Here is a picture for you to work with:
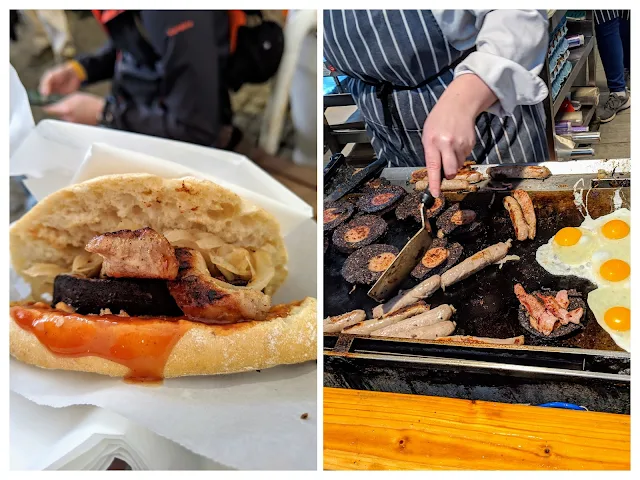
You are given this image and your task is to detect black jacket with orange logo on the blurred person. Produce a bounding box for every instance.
[77,10,232,146]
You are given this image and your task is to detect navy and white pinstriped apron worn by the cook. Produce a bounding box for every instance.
[324,10,548,167]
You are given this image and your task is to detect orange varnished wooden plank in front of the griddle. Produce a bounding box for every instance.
[324,388,631,470]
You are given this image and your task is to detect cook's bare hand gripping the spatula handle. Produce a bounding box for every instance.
[422,74,497,197]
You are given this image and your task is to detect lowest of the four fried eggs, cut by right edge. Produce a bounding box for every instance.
[587,287,631,352]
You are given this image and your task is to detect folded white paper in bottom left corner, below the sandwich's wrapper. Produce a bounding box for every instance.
[9,392,220,470]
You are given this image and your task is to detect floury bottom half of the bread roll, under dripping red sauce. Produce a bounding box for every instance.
[9,298,317,378]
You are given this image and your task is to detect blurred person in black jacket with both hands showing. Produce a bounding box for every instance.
[39,10,283,161]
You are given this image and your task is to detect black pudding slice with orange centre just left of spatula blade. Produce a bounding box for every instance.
[342,244,400,285]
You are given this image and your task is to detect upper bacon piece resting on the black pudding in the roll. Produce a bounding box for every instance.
[85,227,178,280]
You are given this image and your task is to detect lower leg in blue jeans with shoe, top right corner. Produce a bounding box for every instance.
[593,10,631,123]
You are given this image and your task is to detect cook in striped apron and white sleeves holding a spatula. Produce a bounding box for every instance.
[324,10,548,195]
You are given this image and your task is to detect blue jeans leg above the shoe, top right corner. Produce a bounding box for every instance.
[596,18,631,92]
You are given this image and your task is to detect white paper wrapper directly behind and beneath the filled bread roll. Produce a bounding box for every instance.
[10,122,317,470]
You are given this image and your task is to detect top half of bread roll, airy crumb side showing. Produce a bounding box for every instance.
[10,174,287,295]
